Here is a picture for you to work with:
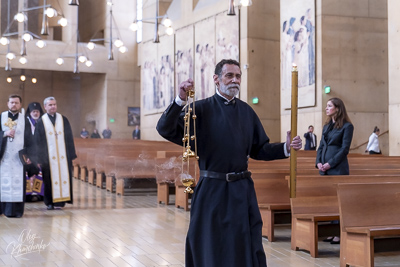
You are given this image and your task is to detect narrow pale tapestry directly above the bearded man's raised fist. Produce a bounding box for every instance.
[175,25,194,97]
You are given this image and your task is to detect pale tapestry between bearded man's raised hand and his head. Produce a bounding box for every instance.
[194,17,215,99]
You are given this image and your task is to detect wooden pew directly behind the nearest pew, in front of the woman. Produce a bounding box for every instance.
[291,175,400,257]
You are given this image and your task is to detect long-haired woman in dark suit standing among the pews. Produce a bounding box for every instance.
[316,98,354,244]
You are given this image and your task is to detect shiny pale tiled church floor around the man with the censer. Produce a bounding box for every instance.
[0,180,400,267]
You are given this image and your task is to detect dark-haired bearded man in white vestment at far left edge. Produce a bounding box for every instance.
[0,95,37,218]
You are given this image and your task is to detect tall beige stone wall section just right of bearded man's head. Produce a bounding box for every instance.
[240,0,282,142]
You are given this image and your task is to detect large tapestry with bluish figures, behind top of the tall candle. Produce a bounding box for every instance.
[280,0,316,109]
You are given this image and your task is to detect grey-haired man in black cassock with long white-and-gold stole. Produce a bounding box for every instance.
[34,96,76,210]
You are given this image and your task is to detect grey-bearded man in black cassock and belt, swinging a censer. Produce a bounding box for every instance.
[157,60,302,267]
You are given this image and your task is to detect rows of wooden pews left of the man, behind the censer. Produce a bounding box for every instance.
[73,139,198,211]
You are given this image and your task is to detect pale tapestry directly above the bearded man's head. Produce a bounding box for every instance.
[215,10,239,63]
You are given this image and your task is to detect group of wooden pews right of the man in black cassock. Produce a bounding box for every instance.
[249,151,400,266]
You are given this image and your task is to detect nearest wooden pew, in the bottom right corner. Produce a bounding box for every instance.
[337,183,400,267]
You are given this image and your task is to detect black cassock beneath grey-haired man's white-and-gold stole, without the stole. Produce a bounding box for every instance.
[34,113,76,207]
